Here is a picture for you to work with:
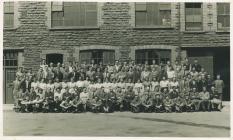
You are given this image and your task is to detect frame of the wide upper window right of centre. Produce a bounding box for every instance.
[134,2,173,29]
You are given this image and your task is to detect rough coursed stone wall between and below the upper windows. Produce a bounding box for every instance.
[3,2,230,70]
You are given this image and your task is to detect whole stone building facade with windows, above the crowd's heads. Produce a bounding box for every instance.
[3,1,230,103]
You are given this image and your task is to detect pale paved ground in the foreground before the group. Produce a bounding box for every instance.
[3,104,230,137]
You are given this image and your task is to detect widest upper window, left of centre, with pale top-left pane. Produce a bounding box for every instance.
[51,2,97,27]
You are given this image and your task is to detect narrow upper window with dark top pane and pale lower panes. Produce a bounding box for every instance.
[185,3,202,31]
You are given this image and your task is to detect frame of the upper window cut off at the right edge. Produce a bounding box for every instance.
[216,2,230,32]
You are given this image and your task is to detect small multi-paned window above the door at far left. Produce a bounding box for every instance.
[3,51,18,67]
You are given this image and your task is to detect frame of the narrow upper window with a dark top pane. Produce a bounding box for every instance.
[184,2,204,32]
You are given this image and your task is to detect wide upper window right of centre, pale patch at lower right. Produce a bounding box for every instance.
[135,2,171,27]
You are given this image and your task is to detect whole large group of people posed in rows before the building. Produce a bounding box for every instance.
[13,58,224,113]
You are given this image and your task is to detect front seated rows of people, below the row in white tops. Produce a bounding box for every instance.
[15,87,222,113]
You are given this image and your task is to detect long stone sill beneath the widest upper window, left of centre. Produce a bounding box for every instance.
[49,26,99,31]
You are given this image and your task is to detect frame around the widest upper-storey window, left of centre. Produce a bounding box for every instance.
[49,1,99,30]
